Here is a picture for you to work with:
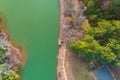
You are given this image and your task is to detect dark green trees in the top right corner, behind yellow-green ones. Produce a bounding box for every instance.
[83,0,120,25]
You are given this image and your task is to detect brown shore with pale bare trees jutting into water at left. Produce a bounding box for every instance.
[0,25,23,80]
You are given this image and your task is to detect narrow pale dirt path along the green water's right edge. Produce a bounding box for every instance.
[57,0,68,80]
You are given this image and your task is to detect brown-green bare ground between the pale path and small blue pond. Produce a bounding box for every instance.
[65,50,94,80]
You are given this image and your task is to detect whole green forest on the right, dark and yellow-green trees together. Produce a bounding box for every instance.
[68,0,120,66]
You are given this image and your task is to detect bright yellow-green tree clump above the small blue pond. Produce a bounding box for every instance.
[68,20,120,66]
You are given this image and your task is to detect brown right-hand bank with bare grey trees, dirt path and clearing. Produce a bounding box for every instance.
[57,0,93,80]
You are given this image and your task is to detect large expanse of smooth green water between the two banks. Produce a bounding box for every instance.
[0,0,59,80]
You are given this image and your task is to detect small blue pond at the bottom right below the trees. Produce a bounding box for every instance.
[94,66,114,80]
